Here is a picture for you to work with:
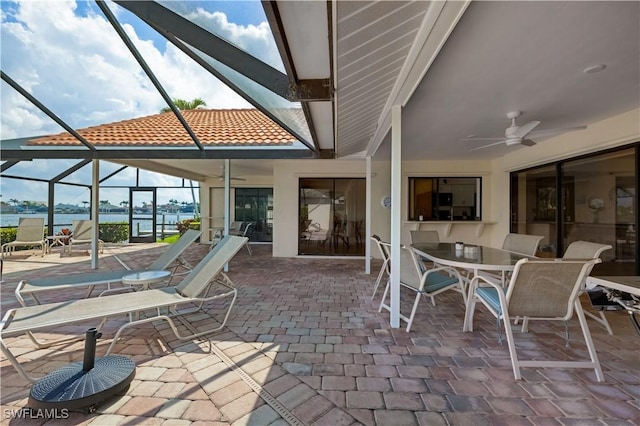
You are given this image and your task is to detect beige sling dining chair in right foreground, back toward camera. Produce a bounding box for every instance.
[463,259,604,382]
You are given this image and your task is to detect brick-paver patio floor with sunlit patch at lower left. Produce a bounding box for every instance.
[0,244,640,425]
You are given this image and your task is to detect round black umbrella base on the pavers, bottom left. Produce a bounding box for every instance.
[27,355,136,413]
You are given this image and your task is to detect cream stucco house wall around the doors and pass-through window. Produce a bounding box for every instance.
[201,109,640,258]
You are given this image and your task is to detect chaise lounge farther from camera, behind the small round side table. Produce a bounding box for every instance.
[15,229,201,306]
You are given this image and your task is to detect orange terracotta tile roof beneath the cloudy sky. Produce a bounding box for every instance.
[29,109,296,147]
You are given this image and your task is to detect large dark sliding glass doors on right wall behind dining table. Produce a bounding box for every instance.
[511,145,640,275]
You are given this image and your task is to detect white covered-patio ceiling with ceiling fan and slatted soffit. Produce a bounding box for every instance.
[298,0,640,159]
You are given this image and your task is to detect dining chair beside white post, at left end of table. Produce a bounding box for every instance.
[378,245,467,332]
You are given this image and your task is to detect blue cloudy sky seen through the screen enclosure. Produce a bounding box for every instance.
[0,0,283,205]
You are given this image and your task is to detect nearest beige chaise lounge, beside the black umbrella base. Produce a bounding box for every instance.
[0,235,247,381]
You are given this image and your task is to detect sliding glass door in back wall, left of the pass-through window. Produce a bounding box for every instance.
[298,178,366,256]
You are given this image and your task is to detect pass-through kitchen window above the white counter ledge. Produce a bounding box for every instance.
[408,177,482,221]
